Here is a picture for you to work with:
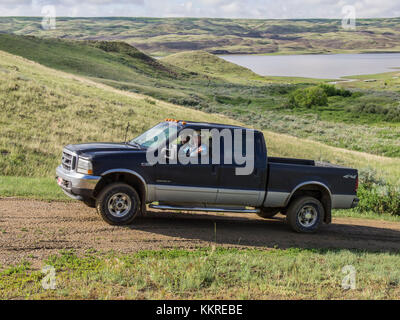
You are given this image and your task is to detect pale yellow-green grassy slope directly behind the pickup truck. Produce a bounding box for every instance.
[0,52,400,186]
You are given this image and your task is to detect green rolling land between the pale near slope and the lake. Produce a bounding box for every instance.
[0,35,400,157]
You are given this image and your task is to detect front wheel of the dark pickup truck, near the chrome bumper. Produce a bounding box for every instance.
[96,183,140,226]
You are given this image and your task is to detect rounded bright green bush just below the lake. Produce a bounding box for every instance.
[289,86,328,108]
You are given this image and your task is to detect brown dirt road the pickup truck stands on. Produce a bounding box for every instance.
[0,199,400,267]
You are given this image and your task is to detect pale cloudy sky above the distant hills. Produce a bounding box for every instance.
[0,0,400,19]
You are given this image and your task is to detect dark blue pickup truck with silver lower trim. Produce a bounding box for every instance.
[56,119,358,232]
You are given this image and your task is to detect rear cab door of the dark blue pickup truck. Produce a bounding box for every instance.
[217,129,267,206]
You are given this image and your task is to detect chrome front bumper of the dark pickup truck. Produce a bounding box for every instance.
[56,166,101,200]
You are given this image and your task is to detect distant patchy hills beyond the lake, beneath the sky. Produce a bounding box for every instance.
[0,17,400,55]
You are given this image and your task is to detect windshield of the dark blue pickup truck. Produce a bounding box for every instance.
[129,122,182,148]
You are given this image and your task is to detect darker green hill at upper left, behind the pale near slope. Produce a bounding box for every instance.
[0,34,190,96]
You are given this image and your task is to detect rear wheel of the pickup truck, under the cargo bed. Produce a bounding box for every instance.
[286,197,325,233]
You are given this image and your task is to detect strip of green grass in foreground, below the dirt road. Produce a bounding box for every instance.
[0,248,400,300]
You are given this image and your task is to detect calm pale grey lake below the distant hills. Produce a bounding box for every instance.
[219,53,400,79]
